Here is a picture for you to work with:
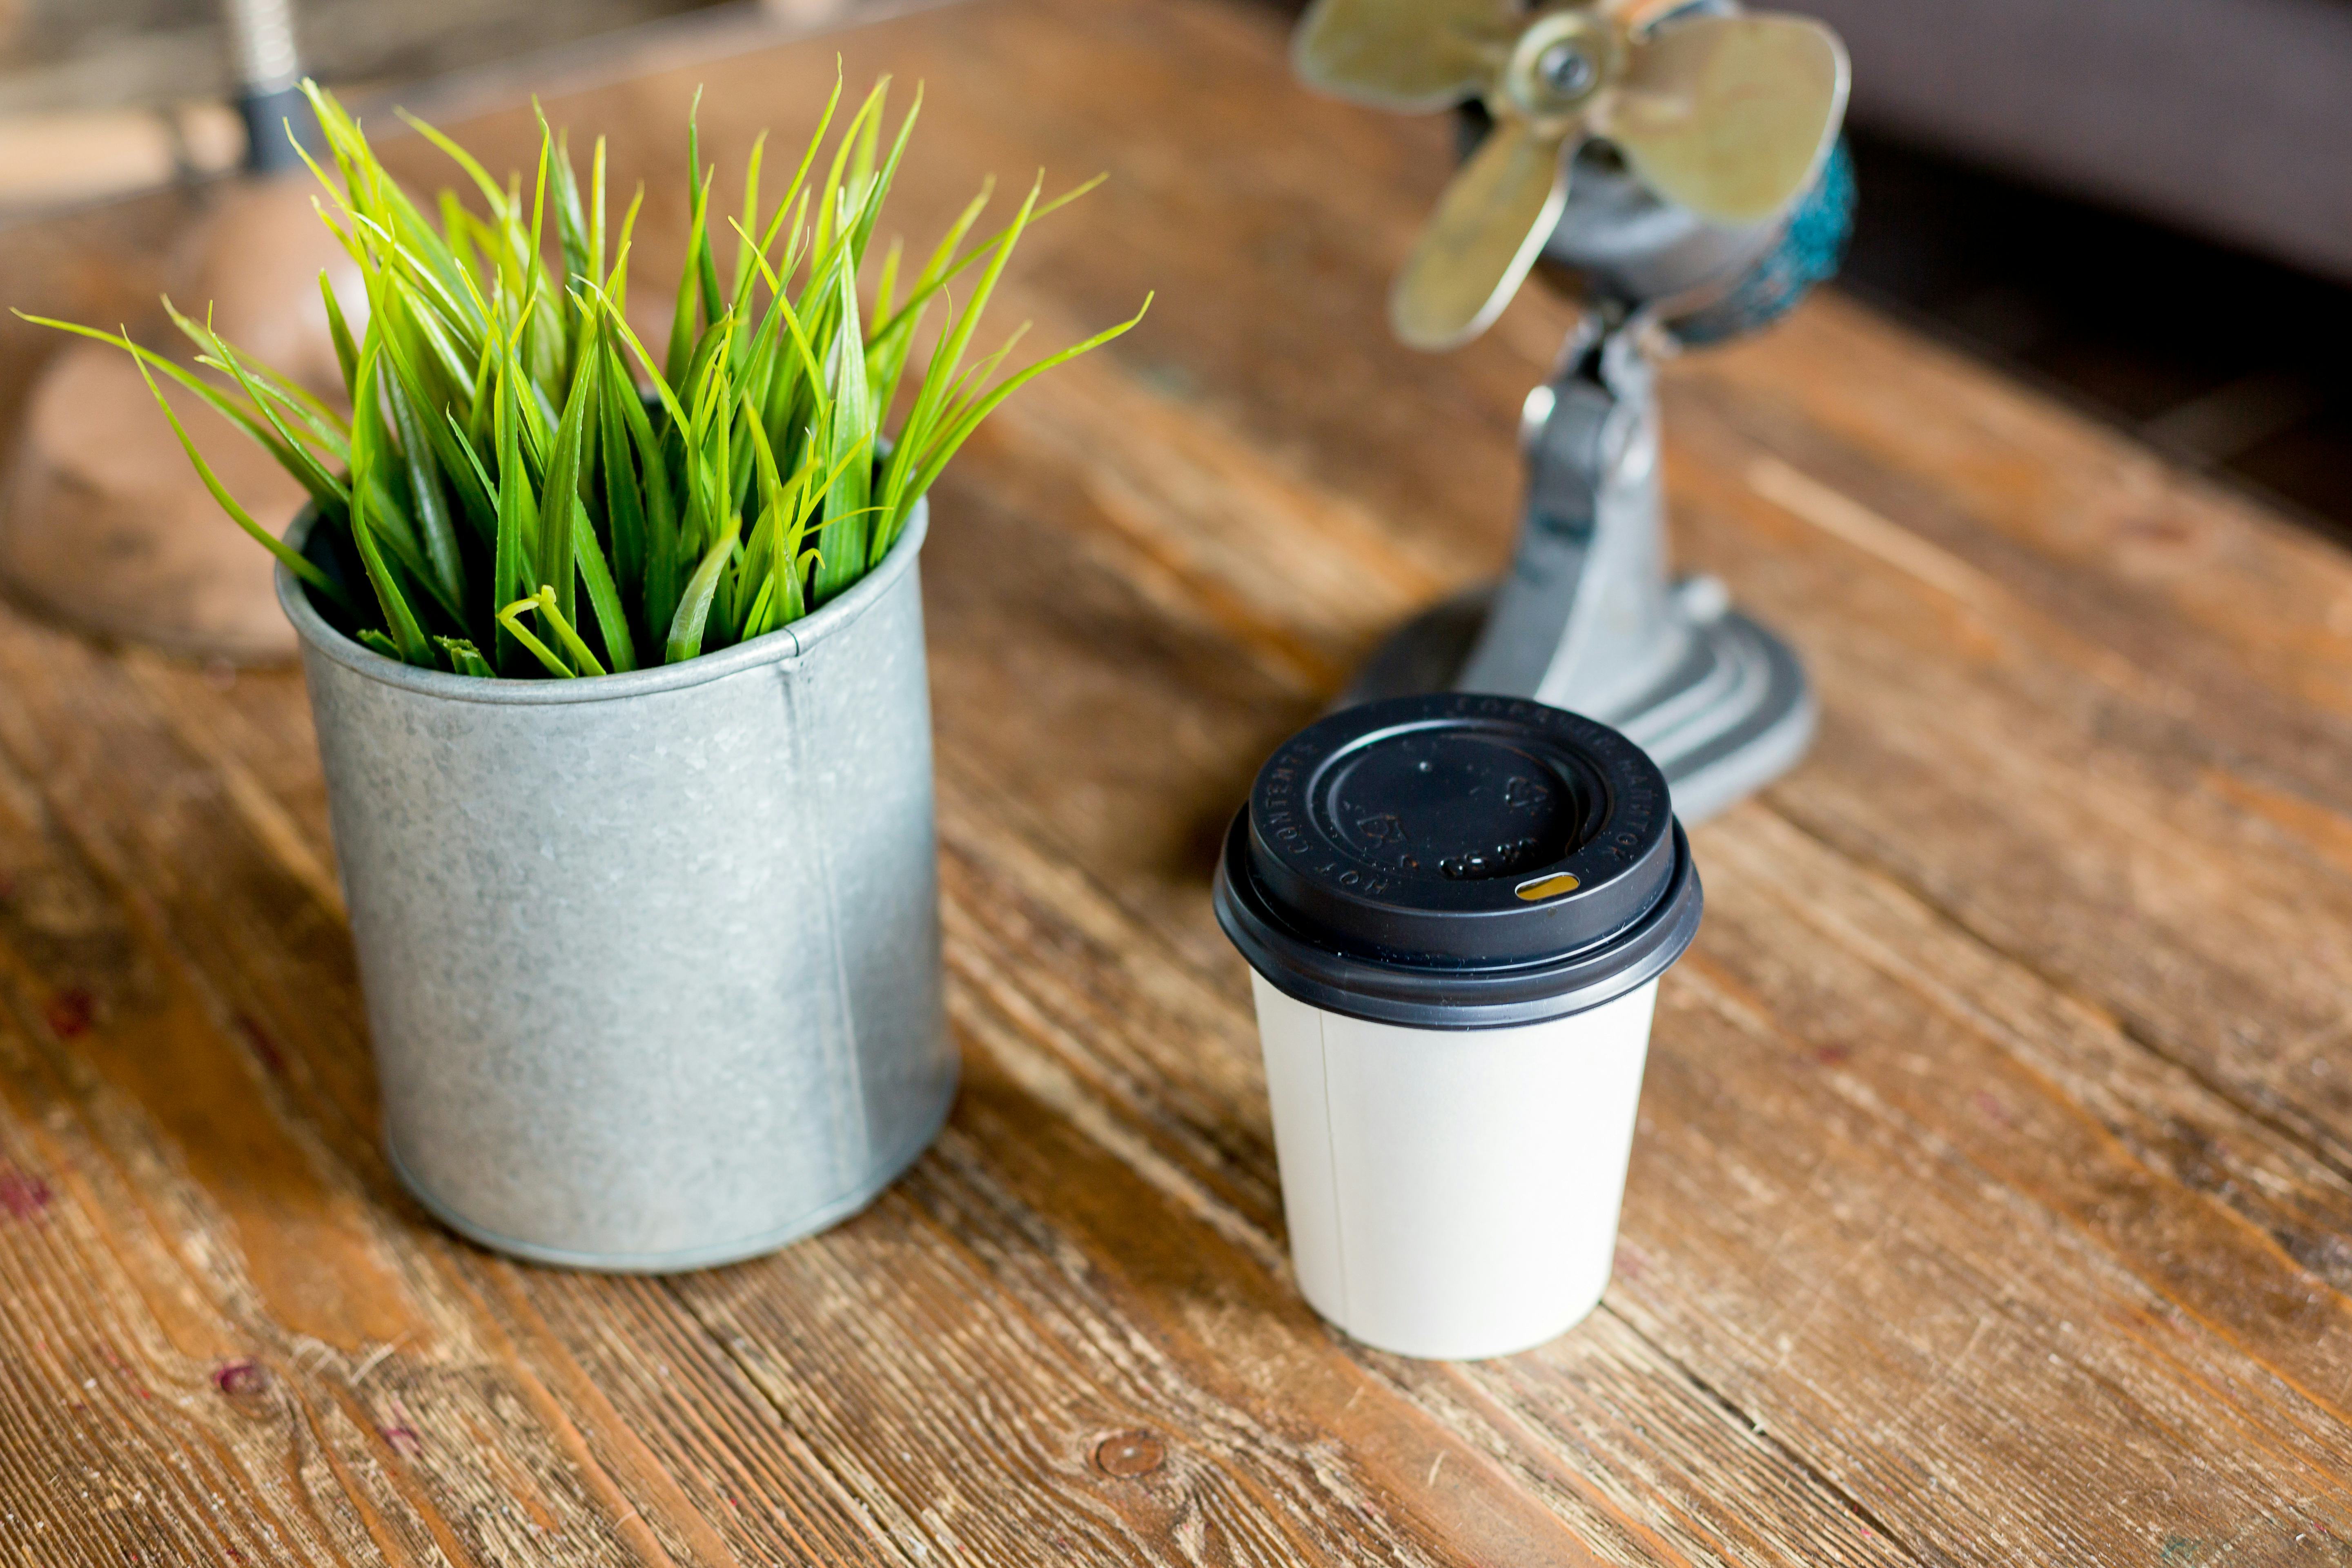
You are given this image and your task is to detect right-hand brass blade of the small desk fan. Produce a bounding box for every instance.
[1595,14,1846,223]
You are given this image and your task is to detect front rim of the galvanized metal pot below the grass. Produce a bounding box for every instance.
[278,496,931,705]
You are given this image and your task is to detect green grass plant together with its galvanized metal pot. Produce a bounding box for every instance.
[27,78,1150,1270]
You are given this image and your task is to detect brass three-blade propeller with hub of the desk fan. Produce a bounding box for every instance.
[1294,0,1846,348]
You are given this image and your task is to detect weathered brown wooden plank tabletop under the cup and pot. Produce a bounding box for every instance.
[0,0,2352,1568]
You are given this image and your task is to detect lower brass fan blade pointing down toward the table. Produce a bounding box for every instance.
[1388,120,1585,348]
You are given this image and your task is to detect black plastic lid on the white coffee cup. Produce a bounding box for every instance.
[1216,693,1700,1030]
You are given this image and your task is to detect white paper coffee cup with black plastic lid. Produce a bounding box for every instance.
[1216,696,1700,1359]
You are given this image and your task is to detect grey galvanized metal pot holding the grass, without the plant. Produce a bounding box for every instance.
[278,506,955,1270]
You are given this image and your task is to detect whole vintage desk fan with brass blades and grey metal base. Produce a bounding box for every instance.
[1294,0,1853,820]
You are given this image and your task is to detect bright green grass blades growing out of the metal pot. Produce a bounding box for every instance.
[28,78,1150,677]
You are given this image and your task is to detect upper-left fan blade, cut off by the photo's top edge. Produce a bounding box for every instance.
[1291,0,1517,113]
